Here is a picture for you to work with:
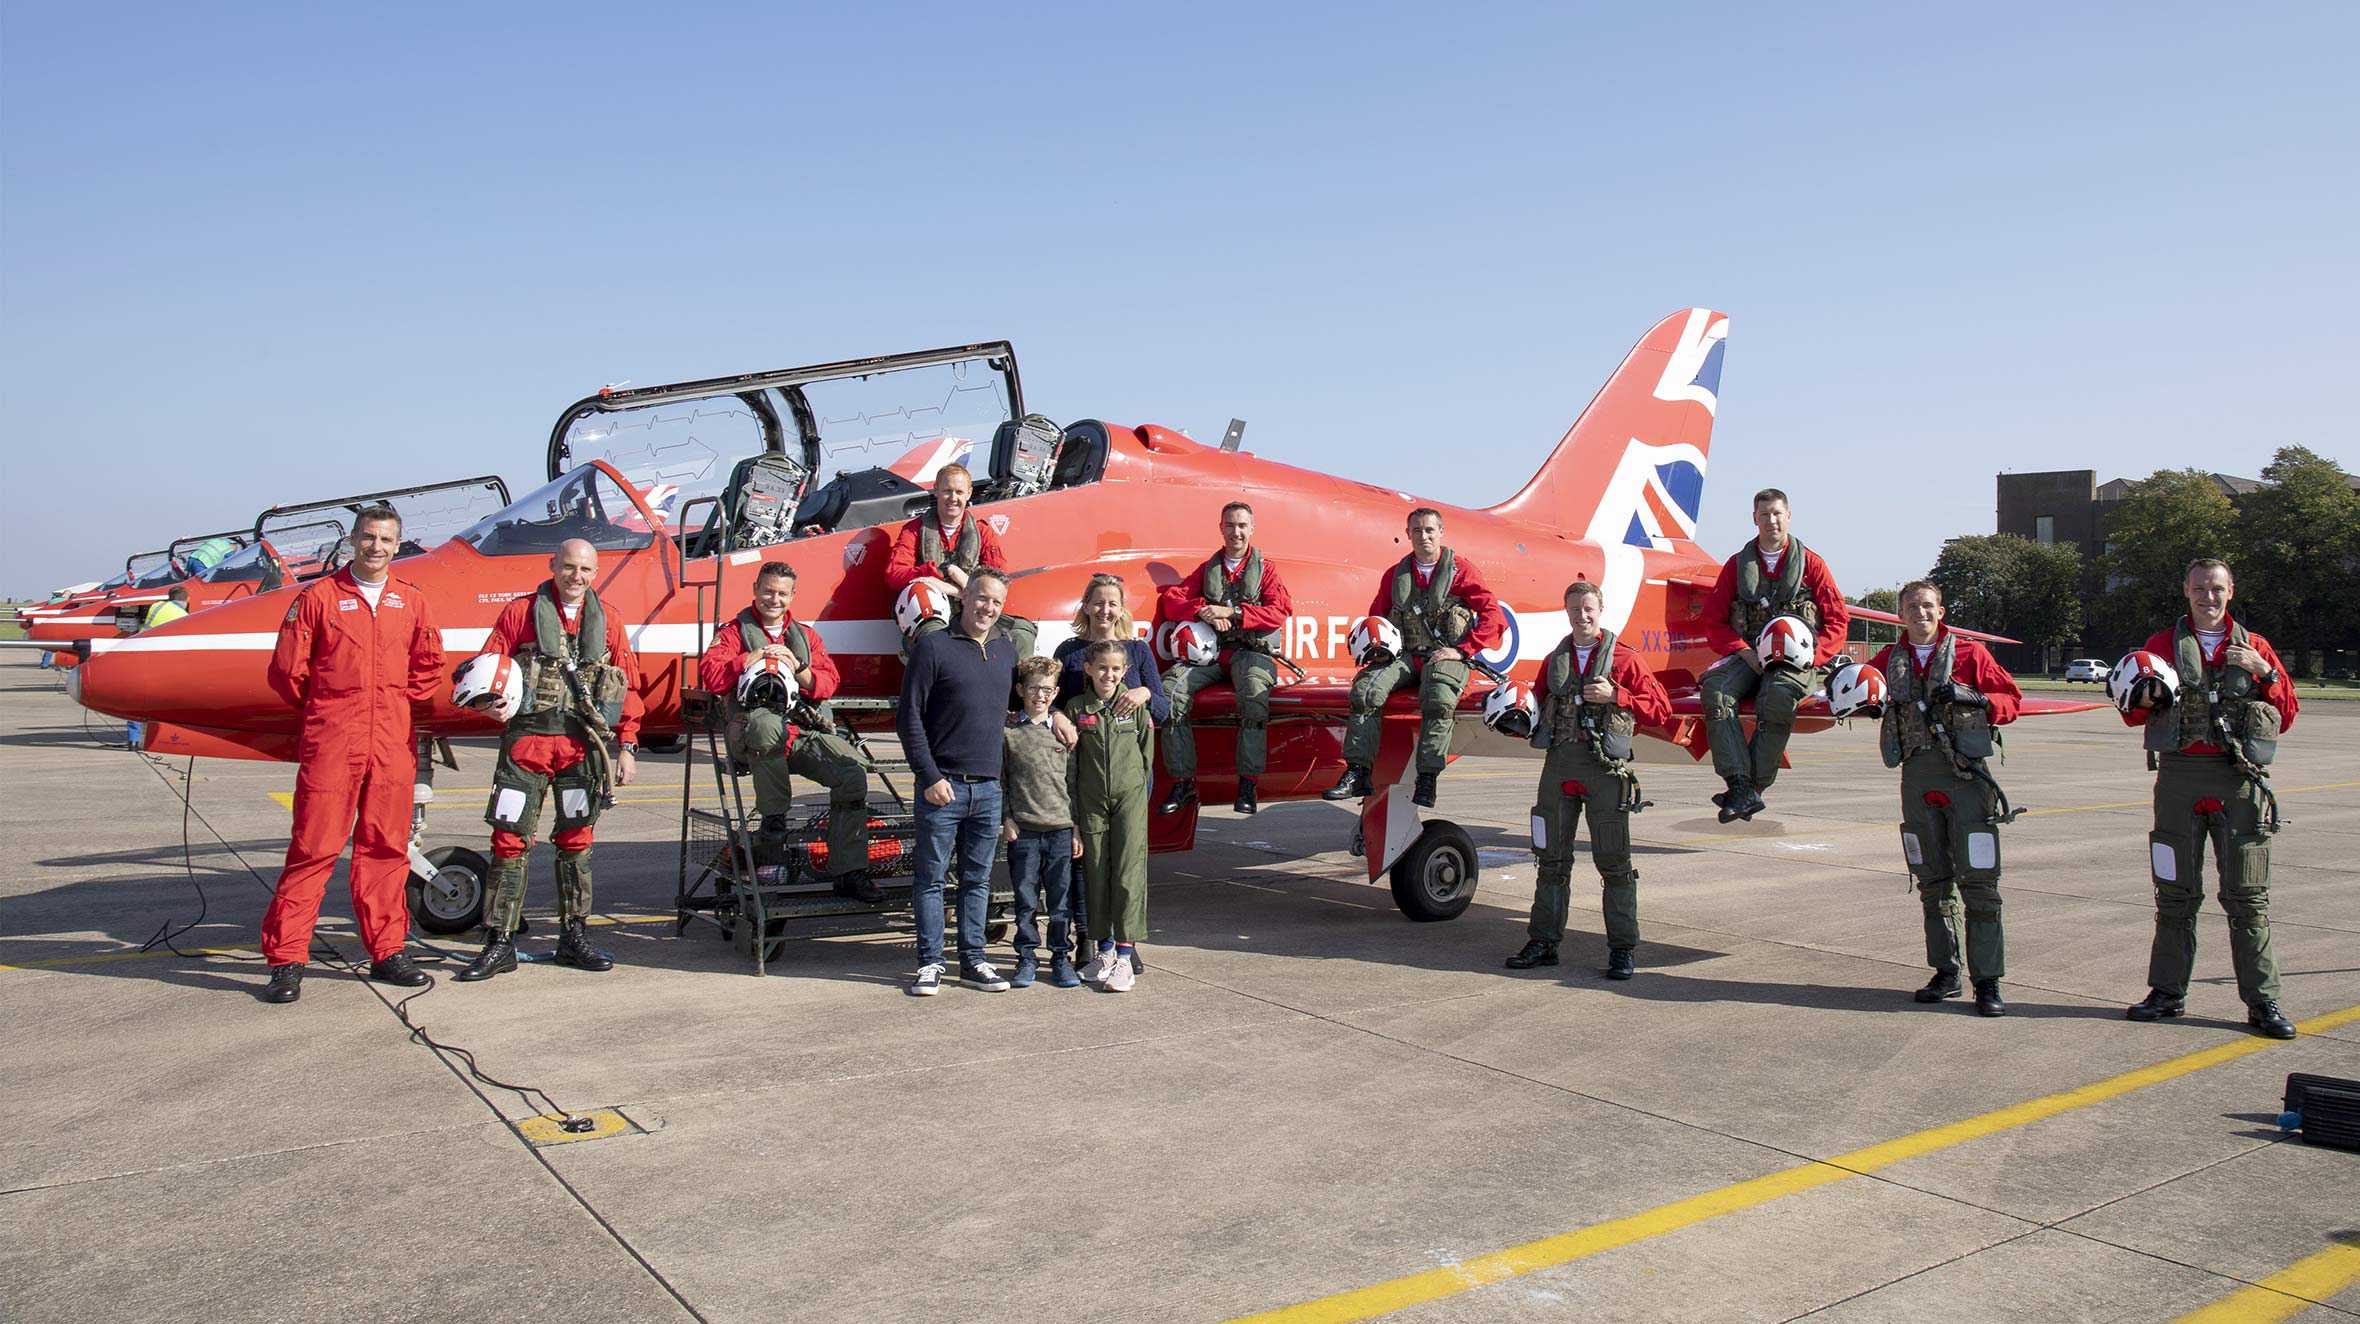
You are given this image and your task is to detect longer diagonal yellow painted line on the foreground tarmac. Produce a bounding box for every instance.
[1241,1005,2360,1324]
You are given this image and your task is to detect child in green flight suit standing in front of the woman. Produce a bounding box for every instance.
[1064,640,1156,994]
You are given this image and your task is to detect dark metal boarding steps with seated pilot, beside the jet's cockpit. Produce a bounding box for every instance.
[673,689,1015,975]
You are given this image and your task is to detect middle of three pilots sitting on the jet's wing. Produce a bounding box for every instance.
[1322,505,1508,810]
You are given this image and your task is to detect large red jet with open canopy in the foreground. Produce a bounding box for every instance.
[76,309,2091,918]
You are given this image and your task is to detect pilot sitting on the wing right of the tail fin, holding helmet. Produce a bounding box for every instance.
[1697,486,1853,824]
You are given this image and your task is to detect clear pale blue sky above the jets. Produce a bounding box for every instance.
[0,0,2360,595]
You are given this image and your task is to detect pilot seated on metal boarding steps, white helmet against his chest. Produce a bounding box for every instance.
[696,562,885,904]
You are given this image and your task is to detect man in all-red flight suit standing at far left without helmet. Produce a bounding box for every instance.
[262,505,441,1003]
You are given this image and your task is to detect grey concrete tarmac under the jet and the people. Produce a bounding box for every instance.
[0,658,2360,1322]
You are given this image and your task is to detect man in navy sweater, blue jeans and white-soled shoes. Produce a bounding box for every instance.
[897,566,1074,998]
